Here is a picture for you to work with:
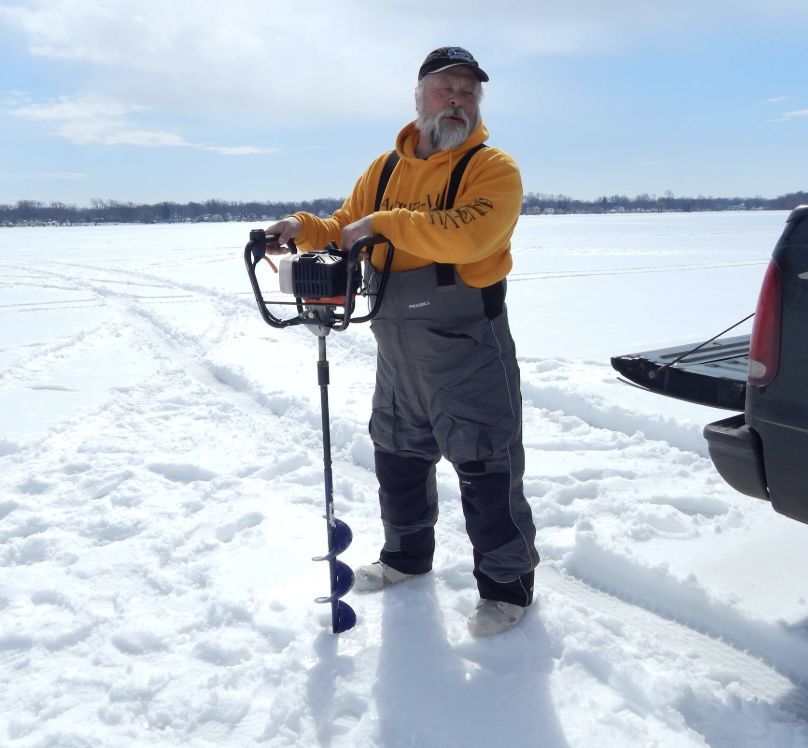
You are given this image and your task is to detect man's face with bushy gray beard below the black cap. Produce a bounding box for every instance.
[416,66,480,150]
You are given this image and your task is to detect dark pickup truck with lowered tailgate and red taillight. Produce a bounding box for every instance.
[611,205,808,523]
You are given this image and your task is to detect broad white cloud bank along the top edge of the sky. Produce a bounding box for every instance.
[6,0,808,122]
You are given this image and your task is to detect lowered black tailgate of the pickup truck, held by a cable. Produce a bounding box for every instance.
[612,335,749,411]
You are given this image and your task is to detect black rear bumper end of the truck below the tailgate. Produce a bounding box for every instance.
[704,414,769,500]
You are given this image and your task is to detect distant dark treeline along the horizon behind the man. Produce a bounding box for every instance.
[0,192,808,226]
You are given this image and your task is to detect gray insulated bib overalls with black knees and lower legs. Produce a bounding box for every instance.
[370,265,539,605]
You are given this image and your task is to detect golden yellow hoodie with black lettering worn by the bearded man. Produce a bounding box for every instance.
[295,121,522,288]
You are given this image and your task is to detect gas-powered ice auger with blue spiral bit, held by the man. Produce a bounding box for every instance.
[244,229,394,634]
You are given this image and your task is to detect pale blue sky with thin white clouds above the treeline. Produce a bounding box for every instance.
[0,0,808,205]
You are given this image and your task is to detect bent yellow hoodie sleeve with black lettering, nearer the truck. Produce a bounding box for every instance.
[373,148,522,265]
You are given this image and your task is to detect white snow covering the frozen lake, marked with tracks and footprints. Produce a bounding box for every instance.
[0,212,808,748]
